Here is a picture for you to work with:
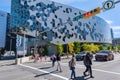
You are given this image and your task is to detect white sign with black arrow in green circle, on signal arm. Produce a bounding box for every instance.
[102,0,115,11]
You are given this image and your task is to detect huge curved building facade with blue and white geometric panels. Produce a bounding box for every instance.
[11,0,111,54]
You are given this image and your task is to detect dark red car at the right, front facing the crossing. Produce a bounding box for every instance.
[95,50,114,61]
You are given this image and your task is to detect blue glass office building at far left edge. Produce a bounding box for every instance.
[0,11,16,51]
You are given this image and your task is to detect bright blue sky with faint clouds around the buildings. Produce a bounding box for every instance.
[0,0,120,38]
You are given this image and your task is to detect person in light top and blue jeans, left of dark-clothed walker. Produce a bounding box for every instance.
[69,55,76,79]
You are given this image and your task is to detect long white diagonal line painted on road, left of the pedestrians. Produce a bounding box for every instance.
[19,64,69,80]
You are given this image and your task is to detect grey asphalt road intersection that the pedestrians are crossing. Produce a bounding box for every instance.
[0,54,120,80]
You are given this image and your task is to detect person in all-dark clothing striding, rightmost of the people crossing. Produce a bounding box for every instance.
[83,52,94,78]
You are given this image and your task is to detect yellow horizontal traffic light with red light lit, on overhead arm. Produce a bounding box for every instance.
[84,7,101,19]
